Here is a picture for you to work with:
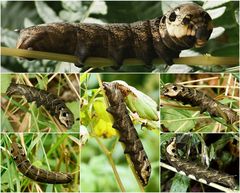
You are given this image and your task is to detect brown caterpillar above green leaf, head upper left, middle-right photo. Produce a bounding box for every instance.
[162,83,239,124]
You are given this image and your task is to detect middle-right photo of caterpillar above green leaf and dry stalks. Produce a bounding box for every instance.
[160,73,240,133]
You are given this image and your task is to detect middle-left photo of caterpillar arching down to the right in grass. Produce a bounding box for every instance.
[1,73,80,132]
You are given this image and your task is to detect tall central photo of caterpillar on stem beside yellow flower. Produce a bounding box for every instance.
[80,74,159,192]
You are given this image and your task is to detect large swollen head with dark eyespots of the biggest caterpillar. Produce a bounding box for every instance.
[160,3,213,49]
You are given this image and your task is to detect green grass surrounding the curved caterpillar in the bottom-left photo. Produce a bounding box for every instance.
[1,134,80,192]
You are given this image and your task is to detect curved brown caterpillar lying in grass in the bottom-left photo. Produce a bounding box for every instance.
[11,142,73,184]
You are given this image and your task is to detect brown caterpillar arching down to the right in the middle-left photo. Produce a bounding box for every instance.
[6,83,74,129]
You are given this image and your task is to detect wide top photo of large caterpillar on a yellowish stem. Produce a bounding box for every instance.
[1,1,239,73]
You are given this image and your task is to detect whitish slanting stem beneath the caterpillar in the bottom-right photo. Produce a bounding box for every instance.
[160,162,237,193]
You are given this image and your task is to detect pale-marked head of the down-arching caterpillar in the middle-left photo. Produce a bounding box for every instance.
[58,107,74,129]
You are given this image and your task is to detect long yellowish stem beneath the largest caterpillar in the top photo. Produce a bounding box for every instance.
[1,47,238,68]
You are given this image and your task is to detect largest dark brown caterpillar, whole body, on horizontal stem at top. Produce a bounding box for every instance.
[17,3,213,67]
